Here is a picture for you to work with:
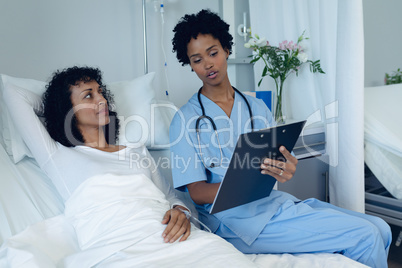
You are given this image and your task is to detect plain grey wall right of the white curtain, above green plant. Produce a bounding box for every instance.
[363,0,402,87]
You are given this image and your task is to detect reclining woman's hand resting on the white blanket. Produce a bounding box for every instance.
[162,206,191,243]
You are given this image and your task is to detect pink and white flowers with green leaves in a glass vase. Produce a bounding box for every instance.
[244,32,325,123]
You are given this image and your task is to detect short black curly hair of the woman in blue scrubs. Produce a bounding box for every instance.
[172,9,233,66]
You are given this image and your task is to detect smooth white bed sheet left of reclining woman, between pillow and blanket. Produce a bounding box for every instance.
[0,146,64,244]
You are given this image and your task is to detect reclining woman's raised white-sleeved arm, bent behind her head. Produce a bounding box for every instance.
[4,86,57,167]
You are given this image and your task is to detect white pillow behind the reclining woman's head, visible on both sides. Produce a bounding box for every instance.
[0,73,177,163]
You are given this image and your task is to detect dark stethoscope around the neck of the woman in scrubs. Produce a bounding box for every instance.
[195,87,254,168]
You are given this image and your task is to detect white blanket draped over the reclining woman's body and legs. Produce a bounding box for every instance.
[65,174,253,267]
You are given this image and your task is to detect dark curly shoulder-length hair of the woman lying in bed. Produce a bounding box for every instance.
[43,66,119,147]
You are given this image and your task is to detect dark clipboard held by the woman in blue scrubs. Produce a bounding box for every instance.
[209,120,306,214]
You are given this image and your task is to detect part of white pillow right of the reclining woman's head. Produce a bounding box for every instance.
[107,72,177,149]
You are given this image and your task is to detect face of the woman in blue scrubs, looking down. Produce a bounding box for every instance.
[187,34,229,86]
